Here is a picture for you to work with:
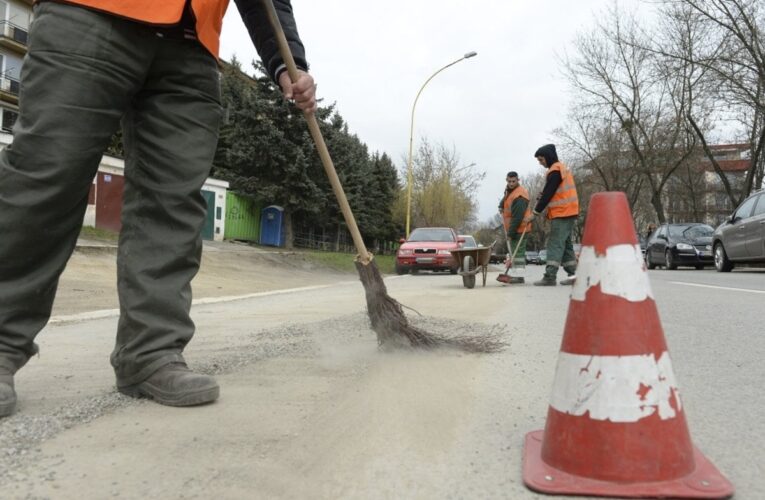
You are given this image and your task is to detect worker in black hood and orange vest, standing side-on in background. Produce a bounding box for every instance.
[532,144,579,286]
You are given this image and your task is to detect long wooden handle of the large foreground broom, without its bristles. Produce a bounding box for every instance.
[262,0,372,264]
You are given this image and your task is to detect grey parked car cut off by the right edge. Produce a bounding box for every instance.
[712,191,765,273]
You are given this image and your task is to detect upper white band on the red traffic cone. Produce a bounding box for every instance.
[571,245,653,302]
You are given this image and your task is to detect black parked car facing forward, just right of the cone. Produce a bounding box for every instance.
[645,222,714,269]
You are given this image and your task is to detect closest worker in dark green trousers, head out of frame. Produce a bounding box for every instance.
[0,0,316,417]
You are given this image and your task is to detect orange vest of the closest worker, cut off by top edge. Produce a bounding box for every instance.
[66,0,229,57]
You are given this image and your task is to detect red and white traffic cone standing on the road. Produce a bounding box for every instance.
[523,192,733,498]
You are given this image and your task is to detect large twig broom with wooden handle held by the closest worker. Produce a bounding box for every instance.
[262,0,505,352]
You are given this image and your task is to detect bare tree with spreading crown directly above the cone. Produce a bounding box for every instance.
[564,6,695,222]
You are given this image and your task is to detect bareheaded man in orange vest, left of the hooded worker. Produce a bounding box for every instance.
[497,171,531,285]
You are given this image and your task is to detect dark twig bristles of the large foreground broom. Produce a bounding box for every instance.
[355,260,506,352]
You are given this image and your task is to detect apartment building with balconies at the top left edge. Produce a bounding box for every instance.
[0,0,34,132]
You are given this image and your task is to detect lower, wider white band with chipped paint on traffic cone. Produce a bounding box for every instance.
[550,352,682,422]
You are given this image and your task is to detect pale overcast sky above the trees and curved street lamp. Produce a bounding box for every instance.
[221,0,620,222]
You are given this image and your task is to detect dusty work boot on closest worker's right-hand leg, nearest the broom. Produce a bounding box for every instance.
[117,363,220,406]
